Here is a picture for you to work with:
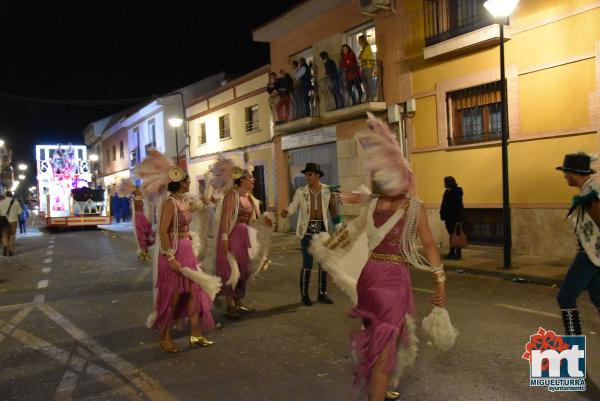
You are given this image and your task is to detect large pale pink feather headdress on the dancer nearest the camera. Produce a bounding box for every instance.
[356,112,416,196]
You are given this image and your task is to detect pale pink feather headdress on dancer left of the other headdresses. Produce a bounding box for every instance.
[136,149,187,194]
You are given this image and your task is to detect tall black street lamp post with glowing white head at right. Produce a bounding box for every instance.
[483,0,519,269]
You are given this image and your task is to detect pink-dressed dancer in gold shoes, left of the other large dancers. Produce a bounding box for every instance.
[137,150,220,353]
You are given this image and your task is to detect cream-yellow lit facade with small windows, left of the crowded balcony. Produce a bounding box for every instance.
[186,66,276,209]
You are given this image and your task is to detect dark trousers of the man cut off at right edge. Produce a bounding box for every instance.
[556,249,600,310]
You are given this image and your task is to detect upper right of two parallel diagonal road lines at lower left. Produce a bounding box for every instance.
[38,304,177,401]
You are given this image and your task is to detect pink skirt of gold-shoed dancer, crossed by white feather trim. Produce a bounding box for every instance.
[154,238,214,331]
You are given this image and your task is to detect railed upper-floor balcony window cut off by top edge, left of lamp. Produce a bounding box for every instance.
[423,0,493,46]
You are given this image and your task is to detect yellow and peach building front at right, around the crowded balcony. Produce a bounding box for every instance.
[254,0,600,257]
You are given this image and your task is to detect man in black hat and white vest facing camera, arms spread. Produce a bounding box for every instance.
[281,163,339,306]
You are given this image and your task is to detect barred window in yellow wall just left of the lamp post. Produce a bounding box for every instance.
[447,81,502,146]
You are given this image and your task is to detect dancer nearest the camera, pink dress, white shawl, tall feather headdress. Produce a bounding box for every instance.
[311,114,457,401]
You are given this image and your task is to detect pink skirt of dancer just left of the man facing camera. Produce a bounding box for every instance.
[217,223,250,298]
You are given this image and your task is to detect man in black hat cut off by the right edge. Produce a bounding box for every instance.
[556,153,600,335]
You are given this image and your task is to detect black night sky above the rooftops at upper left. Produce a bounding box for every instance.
[0,0,300,190]
